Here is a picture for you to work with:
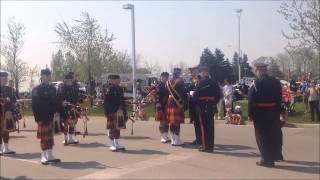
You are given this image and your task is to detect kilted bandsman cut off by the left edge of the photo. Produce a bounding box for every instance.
[0,71,16,155]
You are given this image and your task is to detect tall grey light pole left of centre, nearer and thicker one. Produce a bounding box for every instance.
[122,4,136,105]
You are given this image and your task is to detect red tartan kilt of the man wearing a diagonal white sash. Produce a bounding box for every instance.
[166,98,184,124]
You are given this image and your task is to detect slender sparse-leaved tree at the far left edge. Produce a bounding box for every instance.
[1,18,28,93]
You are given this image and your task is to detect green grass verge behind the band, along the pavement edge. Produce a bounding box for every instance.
[21,98,319,123]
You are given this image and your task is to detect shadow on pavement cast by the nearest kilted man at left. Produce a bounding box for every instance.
[51,161,108,169]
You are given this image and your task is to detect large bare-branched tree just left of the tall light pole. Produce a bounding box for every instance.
[55,12,114,98]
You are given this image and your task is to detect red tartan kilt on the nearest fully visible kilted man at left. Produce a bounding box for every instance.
[37,123,54,150]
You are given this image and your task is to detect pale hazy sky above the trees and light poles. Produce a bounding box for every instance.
[1,1,288,75]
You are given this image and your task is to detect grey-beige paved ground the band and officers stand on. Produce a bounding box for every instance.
[0,117,320,179]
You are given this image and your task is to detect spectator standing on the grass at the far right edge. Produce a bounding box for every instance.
[307,82,320,121]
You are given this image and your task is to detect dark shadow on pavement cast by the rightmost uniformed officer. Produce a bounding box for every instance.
[275,160,320,174]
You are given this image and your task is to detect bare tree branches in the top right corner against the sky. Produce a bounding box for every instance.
[278,0,320,52]
